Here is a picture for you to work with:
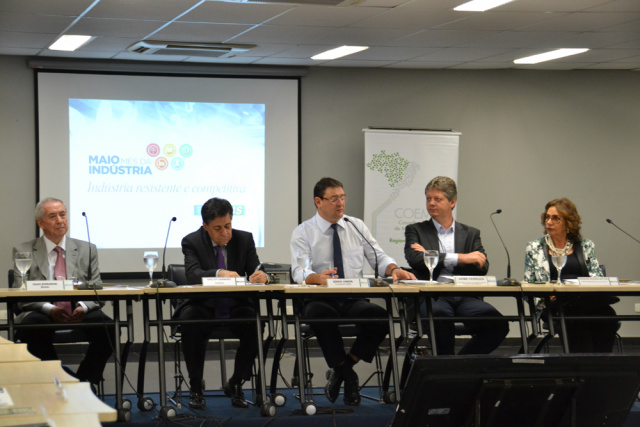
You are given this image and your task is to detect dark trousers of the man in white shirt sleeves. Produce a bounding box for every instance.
[304,298,389,368]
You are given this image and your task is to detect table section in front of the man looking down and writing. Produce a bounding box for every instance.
[138,284,284,418]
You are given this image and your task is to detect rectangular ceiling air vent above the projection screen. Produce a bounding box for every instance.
[127,40,256,58]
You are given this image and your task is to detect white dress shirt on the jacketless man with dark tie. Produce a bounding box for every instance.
[290,213,396,283]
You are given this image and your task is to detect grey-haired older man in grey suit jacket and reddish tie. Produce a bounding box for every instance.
[13,198,114,384]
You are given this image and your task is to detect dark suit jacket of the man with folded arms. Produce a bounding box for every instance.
[404,219,489,280]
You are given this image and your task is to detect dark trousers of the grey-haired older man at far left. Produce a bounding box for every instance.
[16,310,115,384]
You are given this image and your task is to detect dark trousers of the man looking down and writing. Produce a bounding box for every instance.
[179,304,262,390]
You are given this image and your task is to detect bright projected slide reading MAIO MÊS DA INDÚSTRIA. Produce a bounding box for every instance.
[69,99,265,248]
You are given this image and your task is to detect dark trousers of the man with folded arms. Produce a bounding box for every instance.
[420,297,509,355]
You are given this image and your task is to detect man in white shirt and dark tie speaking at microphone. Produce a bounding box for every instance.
[290,178,415,405]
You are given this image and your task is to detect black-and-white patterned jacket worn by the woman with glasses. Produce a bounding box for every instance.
[524,237,603,283]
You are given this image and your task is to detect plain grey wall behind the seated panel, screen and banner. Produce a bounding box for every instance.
[0,56,640,336]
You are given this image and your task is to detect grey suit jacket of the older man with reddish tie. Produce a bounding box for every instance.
[12,236,104,322]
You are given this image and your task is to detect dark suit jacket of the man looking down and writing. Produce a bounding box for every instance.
[174,227,260,316]
